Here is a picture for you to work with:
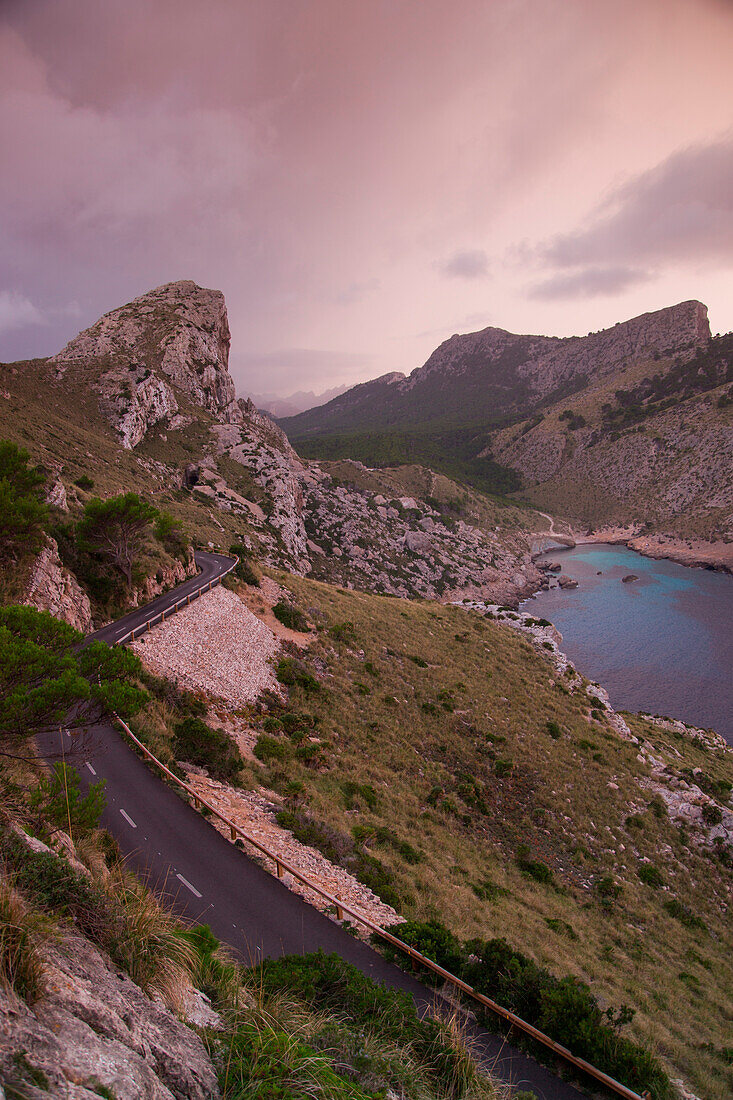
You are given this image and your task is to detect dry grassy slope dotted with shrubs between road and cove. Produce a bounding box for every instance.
[249,578,732,1100]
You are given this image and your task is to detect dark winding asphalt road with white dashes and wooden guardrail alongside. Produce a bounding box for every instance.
[59,552,584,1100]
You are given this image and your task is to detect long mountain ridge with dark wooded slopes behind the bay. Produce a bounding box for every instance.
[280,301,733,539]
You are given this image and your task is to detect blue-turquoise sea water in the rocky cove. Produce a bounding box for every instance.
[523,543,733,745]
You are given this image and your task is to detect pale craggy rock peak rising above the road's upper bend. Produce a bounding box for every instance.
[51,279,241,448]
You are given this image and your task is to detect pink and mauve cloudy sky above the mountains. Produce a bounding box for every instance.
[0,0,733,394]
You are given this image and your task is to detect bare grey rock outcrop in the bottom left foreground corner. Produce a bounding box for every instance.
[0,934,219,1100]
